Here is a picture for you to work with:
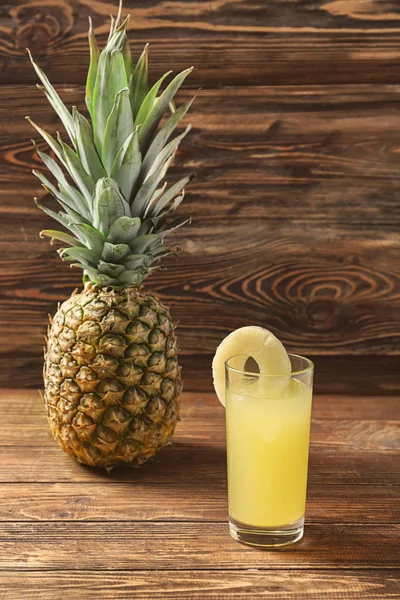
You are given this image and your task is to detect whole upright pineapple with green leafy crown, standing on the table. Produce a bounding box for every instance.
[27,10,192,469]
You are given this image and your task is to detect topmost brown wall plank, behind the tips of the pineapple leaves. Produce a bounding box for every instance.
[0,0,400,87]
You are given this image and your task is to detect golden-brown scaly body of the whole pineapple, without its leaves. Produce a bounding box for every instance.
[44,284,182,470]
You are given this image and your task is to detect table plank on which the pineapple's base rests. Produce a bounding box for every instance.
[0,436,400,490]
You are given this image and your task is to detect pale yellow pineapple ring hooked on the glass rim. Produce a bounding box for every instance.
[212,325,291,406]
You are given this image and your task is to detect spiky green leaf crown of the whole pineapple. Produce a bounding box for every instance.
[27,5,193,288]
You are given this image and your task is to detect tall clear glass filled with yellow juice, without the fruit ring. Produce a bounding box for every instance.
[225,354,314,547]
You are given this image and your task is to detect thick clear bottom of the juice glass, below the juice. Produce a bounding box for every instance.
[229,517,304,548]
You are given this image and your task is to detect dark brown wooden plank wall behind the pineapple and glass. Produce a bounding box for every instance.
[0,0,400,393]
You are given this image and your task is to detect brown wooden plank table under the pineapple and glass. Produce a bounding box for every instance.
[0,390,400,600]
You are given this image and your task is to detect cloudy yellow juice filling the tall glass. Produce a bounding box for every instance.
[226,378,312,528]
